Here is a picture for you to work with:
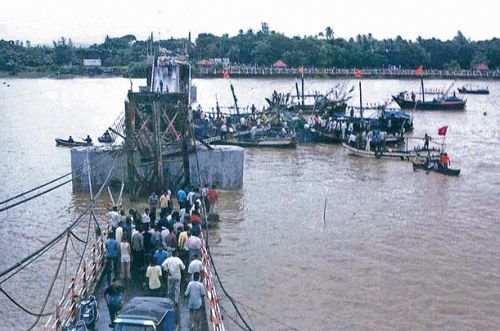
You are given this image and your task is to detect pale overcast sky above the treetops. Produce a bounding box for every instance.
[0,0,500,44]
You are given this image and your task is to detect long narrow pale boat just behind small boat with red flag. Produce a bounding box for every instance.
[342,143,439,161]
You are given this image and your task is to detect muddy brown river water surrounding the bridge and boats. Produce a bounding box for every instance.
[0,78,500,331]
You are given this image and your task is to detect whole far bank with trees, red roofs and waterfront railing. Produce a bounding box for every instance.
[0,23,500,79]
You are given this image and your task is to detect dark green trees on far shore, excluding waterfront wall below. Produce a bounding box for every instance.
[0,23,500,77]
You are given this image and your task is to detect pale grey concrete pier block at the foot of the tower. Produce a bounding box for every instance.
[71,146,245,192]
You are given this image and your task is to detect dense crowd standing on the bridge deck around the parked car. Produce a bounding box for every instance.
[103,185,218,330]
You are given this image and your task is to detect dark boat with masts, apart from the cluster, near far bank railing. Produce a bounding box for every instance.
[392,78,467,111]
